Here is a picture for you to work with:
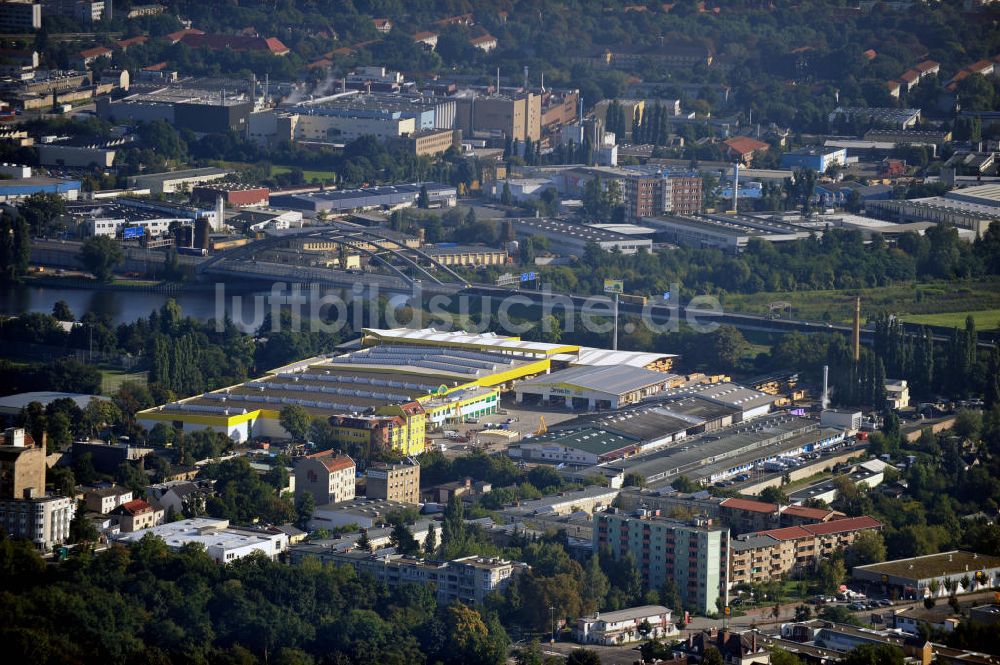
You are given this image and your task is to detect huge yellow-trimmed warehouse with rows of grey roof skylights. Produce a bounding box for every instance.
[138,328,670,455]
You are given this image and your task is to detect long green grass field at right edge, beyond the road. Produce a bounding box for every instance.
[723,277,1000,330]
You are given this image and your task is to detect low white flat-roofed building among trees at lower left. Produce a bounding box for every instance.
[116,517,288,564]
